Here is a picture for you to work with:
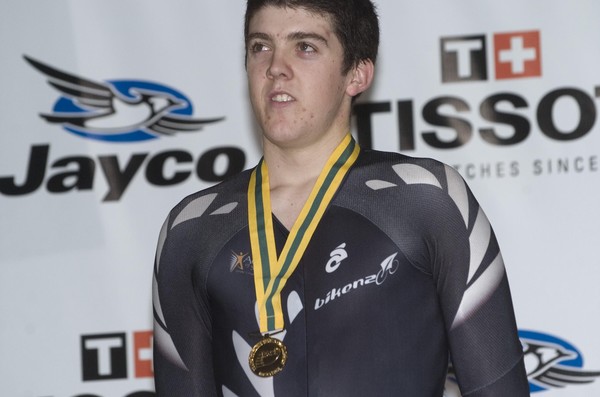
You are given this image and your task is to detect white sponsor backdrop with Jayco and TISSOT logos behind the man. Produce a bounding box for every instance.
[0,0,600,397]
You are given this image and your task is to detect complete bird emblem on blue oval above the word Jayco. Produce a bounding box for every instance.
[23,55,224,142]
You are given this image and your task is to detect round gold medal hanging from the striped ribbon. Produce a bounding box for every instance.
[248,336,287,378]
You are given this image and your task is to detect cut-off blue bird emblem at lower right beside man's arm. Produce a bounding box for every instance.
[519,330,600,392]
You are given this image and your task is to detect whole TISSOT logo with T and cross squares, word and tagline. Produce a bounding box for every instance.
[353,25,600,156]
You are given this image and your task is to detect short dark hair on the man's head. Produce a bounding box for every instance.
[244,0,379,74]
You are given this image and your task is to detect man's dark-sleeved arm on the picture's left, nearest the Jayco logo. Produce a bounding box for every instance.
[153,215,217,397]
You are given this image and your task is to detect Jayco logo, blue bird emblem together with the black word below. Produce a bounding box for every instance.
[0,56,246,202]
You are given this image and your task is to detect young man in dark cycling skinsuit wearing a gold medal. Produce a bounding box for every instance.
[154,0,528,397]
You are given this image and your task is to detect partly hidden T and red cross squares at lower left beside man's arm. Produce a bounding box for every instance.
[81,331,154,381]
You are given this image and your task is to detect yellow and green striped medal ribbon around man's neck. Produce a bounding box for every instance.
[248,134,360,333]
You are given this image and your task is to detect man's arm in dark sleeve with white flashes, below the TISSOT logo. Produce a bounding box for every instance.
[434,167,529,397]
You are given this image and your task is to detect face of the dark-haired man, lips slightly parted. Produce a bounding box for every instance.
[246,6,352,147]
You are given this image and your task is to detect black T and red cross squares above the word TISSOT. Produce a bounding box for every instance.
[440,30,542,83]
